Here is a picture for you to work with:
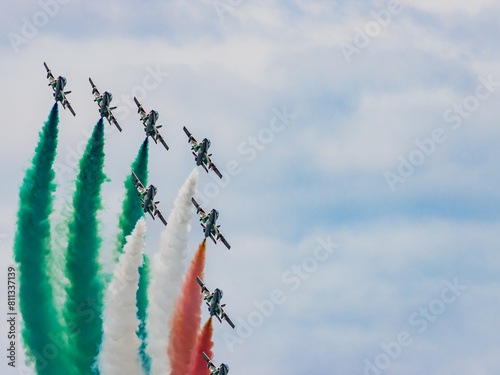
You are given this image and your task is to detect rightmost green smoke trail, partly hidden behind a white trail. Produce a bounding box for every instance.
[116,137,151,374]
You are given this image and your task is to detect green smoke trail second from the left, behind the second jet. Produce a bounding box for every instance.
[64,119,106,375]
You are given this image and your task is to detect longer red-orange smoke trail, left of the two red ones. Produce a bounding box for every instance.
[167,239,206,375]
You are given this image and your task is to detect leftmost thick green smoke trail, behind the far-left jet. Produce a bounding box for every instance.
[14,103,73,375]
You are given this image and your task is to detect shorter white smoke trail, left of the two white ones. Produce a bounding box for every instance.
[98,218,146,375]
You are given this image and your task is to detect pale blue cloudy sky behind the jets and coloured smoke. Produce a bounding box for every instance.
[0,0,500,375]
